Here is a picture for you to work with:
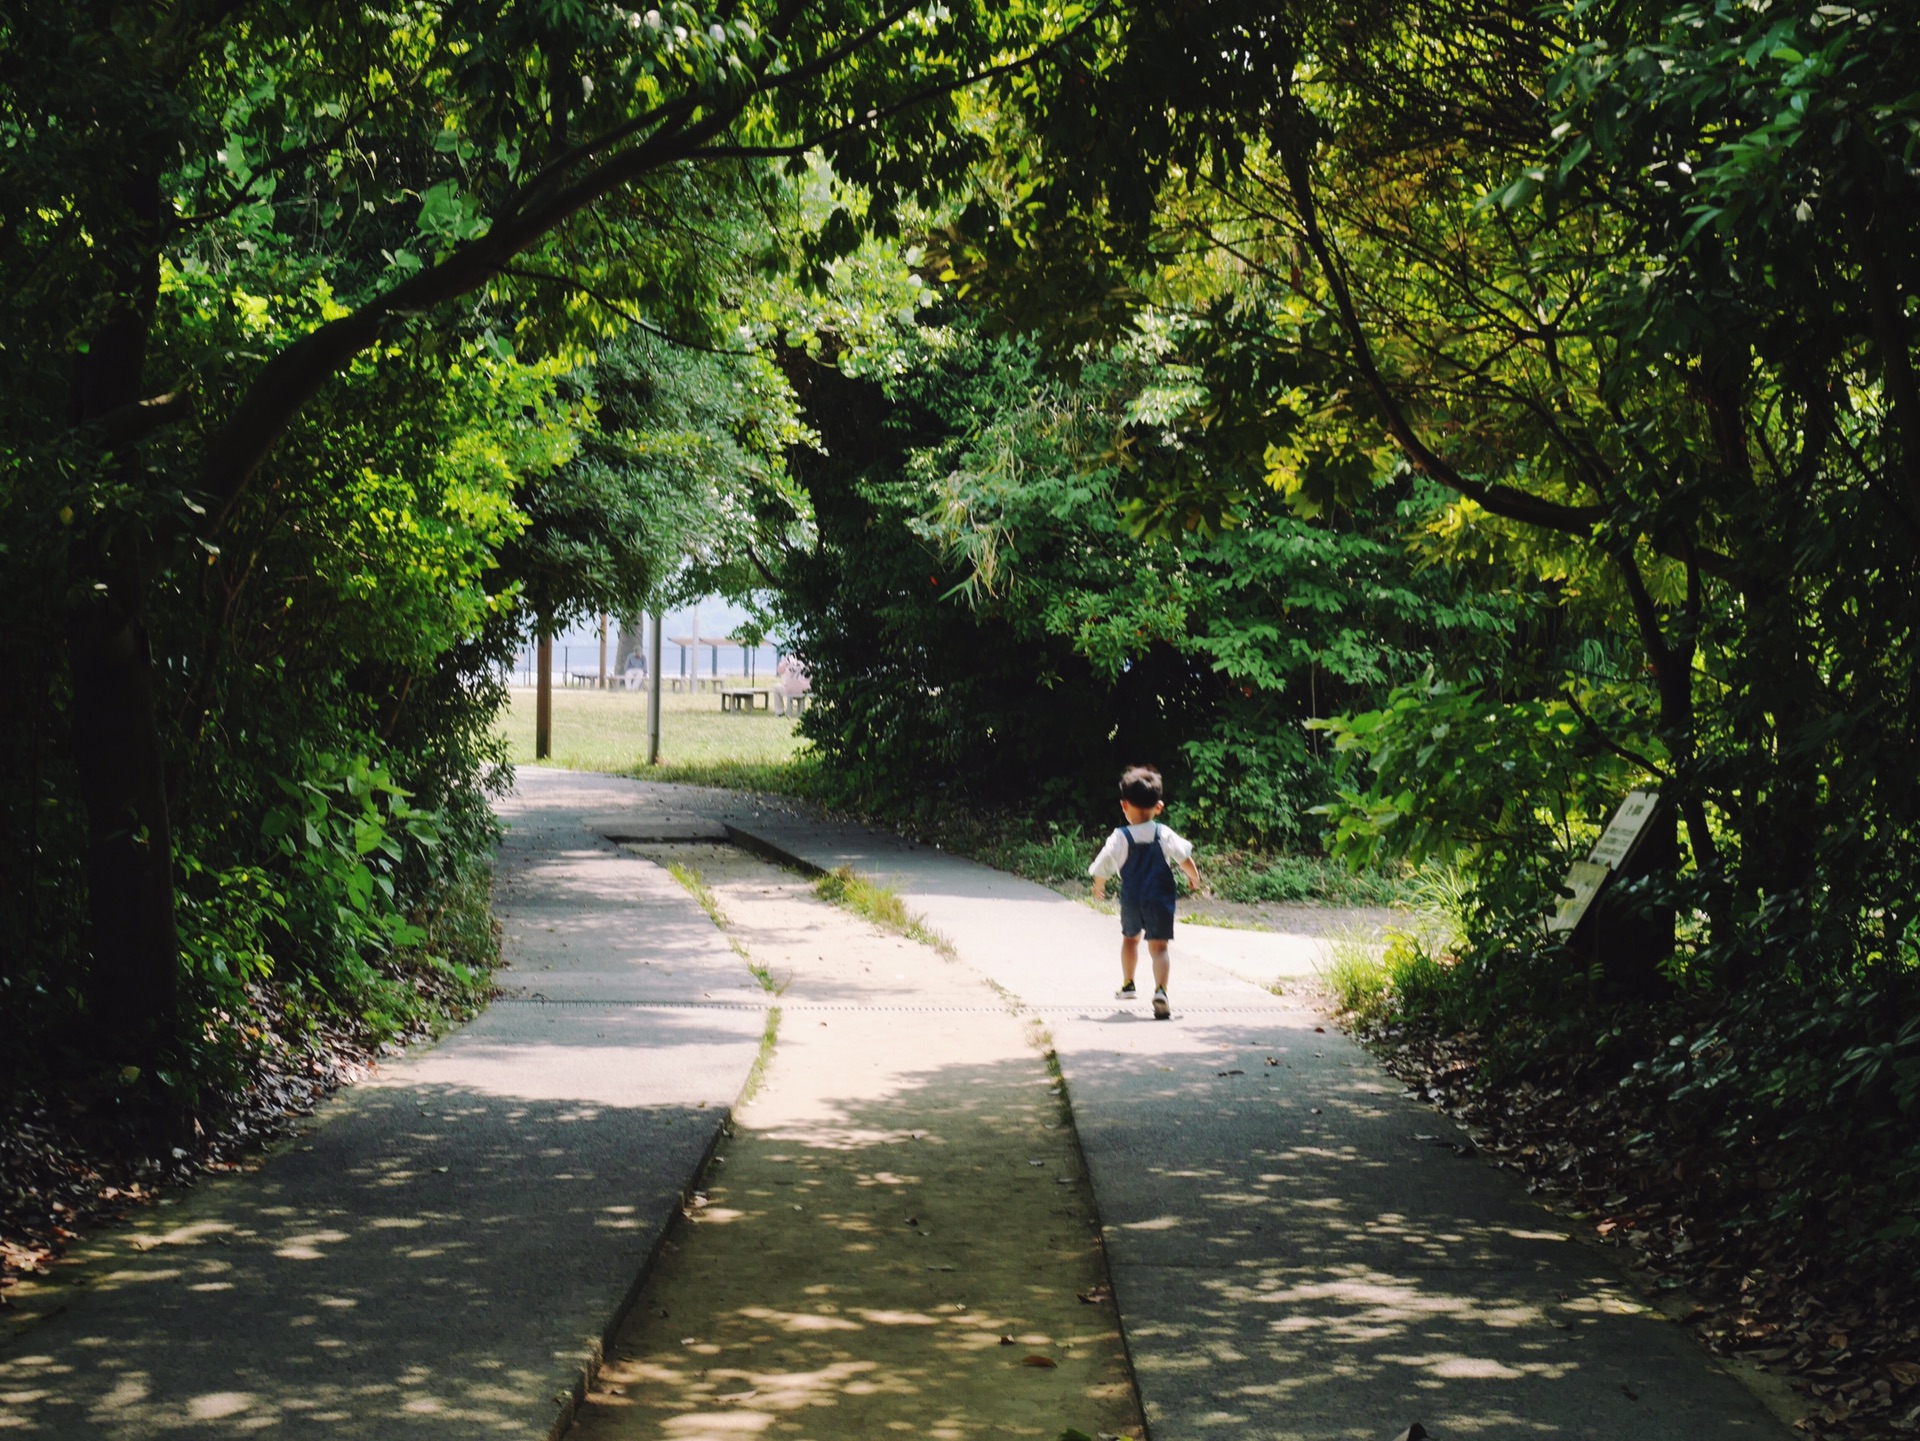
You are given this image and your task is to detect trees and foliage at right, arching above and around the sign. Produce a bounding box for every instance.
[921,0,1920,1243]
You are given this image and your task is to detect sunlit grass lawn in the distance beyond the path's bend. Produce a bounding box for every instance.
[501,687,804,781]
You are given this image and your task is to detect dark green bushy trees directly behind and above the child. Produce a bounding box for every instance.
[780,317,1511,832]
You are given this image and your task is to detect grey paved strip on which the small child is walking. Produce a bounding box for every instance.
[564,777,1784,1441]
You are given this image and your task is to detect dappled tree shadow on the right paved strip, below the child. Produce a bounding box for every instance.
[1069,1009,1782,1441]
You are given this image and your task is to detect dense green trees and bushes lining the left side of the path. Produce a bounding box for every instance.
[0,0,1083,1117]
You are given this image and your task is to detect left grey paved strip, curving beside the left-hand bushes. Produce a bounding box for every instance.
[0,777,764,1441]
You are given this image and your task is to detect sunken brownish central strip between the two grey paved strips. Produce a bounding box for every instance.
[574,848,1137,1441]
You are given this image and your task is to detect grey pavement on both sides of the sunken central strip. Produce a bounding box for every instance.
[0,769,1780,1441]
